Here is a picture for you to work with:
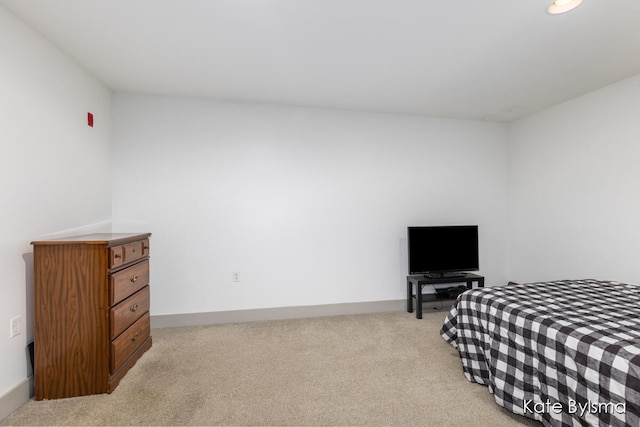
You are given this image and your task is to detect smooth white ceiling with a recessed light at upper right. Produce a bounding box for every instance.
[0,0,640,121]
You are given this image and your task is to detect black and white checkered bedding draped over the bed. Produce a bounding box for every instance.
[440,280,640,427]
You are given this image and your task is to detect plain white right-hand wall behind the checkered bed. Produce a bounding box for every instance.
[509,76,640,283]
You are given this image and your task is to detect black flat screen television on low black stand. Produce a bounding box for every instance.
[407,225,480,277]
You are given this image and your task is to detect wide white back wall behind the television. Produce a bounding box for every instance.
[113,94,508,315]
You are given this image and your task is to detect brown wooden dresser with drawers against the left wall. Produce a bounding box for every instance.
[31,233,151,400]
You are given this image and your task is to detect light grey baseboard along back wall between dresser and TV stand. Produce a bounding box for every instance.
[151,299,409,328]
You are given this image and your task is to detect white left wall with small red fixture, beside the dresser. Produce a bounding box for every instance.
[0,6,111,404]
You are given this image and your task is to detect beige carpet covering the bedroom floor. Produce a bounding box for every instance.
[0,309,540,426]
